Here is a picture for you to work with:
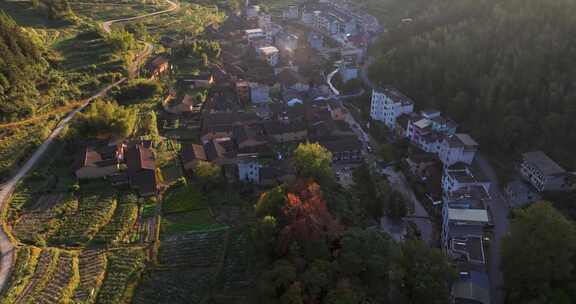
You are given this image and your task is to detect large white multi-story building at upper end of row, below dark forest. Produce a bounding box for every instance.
[370,87,414,129]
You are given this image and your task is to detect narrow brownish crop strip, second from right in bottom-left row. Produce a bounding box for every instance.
[72,250,106,304]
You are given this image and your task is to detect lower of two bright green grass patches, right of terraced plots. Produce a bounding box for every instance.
[161,209,224,234]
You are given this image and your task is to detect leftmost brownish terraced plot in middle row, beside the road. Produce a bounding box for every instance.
[14,193,78,245]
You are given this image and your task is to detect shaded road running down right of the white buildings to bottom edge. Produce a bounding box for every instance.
[475,154,510,304]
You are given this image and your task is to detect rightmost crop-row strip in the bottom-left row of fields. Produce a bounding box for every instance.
[97,248,145,304]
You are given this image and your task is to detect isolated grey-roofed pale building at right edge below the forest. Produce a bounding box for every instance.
[520,151,575,192]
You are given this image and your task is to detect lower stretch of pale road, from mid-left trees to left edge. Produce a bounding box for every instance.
[0,78,126,290]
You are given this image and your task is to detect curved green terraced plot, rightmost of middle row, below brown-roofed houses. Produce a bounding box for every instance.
[93,195,138,244]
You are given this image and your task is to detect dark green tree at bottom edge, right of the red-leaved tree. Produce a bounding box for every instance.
[400,240,456,304]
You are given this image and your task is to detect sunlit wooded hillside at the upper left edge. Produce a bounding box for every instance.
[0,11,46,121]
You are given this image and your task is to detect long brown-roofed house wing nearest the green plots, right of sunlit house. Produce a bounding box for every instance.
[126,144,158,196]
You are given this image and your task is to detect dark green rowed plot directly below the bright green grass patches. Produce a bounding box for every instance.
[158,229,228,267]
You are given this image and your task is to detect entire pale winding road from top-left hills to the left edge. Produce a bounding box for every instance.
[0,0,180,291]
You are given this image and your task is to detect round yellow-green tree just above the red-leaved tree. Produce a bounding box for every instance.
[294,143,332,181]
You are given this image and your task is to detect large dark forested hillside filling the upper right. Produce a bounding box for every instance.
[370,0,576,168]
